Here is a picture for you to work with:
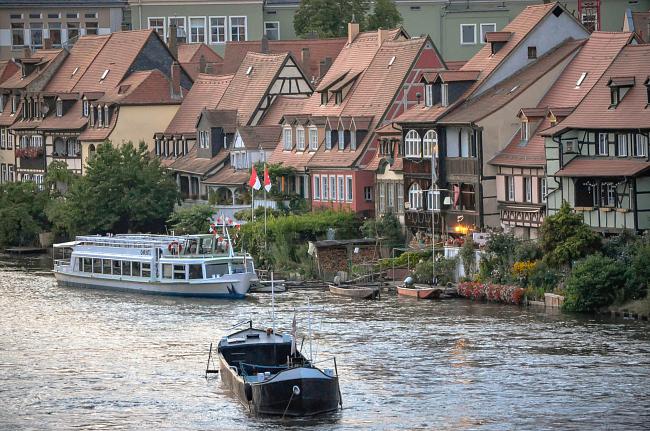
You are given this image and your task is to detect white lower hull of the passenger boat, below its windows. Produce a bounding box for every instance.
[54,270,255,299]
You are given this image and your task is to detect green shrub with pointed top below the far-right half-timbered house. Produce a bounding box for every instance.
[539,202,601,266]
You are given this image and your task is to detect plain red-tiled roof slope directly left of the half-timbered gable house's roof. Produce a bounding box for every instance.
[164,74,232,135]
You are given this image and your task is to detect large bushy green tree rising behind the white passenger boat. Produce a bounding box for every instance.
[48,142,179,235]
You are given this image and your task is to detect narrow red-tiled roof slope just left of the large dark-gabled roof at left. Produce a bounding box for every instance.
[45,35,110,93]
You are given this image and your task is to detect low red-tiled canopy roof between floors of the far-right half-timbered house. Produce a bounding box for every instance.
[554,157,650,177]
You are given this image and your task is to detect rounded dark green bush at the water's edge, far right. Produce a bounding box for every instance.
[564,254,625,312]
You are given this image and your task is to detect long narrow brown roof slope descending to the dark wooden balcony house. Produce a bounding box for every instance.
[439,40,585,124]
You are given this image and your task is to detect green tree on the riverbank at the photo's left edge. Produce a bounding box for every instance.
[0,182,49,246]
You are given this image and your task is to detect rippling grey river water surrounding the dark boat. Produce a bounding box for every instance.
[0,256,650,430]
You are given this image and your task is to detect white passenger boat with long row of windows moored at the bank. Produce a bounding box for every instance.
[54,226,257,298]
